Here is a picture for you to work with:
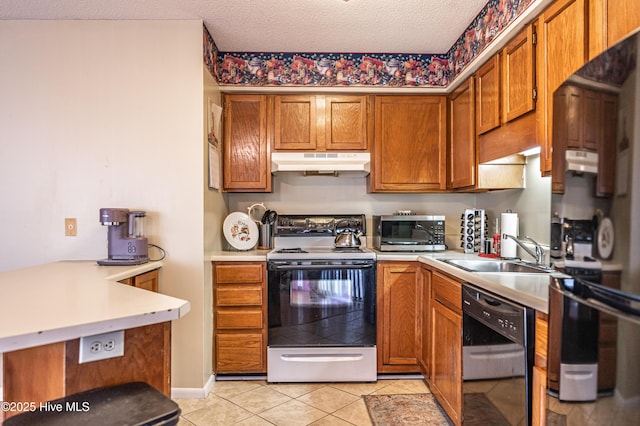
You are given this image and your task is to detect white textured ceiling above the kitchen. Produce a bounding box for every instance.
[0,0,487,53]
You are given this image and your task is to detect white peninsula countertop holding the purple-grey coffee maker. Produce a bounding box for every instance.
[0,261,190,352]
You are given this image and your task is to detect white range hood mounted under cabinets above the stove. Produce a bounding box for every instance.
[271,152,371,176]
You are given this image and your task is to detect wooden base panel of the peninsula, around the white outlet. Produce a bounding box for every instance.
[2,322,171,418]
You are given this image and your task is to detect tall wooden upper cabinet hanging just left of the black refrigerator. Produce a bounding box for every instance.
[536,0,588,175]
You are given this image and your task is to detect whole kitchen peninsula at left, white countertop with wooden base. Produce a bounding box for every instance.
[0,261,190,421]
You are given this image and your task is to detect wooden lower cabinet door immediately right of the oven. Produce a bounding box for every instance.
[377,261,422,373]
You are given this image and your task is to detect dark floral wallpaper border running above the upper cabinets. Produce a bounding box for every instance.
[203,0,534,87]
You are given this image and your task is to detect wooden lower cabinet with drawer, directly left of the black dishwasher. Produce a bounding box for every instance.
[429,271,463,425]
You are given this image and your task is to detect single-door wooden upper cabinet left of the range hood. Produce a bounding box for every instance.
[223,95,271,192]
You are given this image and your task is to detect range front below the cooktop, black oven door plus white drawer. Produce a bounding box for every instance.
[267,260,377,382]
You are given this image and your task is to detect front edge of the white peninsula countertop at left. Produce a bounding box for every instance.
[0,302,191,353]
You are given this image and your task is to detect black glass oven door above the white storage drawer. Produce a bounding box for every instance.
[268,260,376,347]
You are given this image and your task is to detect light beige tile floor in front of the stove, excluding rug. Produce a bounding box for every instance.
[176,379,430,426]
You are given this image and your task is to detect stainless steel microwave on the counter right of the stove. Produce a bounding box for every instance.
[373,215,446,251]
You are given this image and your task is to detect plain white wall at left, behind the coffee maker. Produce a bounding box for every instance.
[0,20,210,387]
